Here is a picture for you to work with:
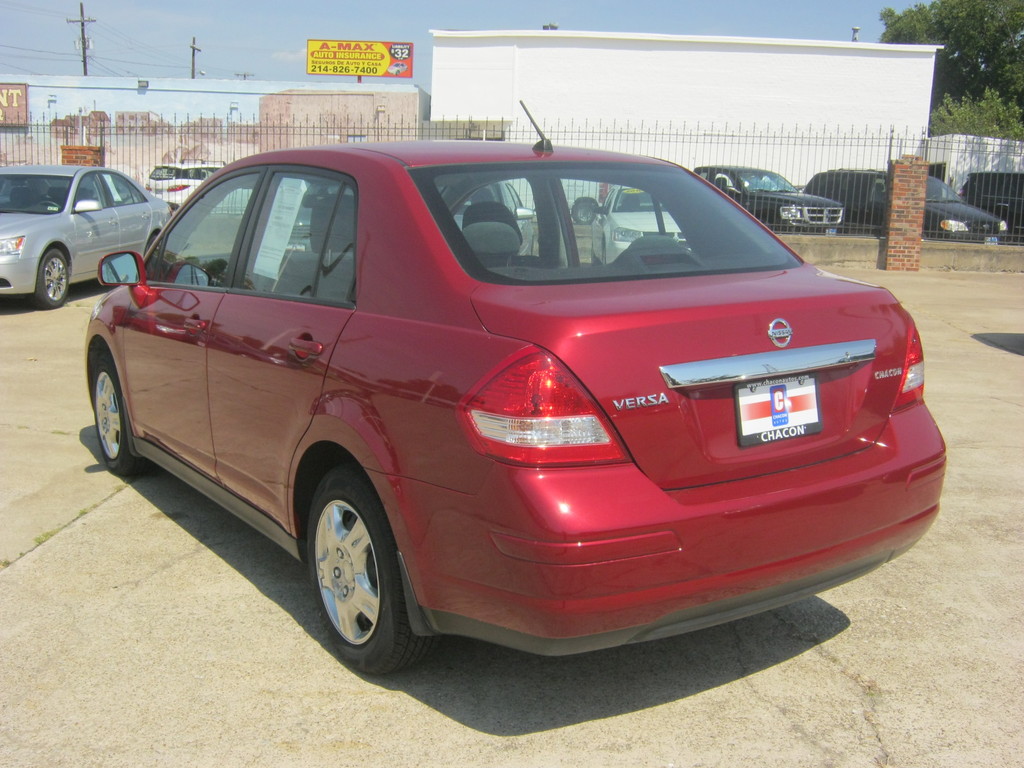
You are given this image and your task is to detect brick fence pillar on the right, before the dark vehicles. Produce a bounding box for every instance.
[886,155,928,272]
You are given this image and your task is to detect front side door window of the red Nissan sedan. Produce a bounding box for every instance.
[146,173,259,287]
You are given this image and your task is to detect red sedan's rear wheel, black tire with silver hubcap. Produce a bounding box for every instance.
[306,468,436,675]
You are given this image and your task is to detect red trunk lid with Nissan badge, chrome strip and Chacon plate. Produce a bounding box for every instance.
[473,265,911,489]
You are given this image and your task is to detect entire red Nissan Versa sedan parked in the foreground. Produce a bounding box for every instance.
[87,142,945,673]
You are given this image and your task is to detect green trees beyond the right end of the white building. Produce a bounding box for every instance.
[880,0,1024,136]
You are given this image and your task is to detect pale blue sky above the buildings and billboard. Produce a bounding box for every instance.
[0,0,913,91]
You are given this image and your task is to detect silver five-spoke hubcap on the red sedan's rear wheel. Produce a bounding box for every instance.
[314,501,381,645]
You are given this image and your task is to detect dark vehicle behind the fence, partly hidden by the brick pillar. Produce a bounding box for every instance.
[804,170,1007,242]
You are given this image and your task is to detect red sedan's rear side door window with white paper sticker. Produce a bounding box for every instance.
[243,171,355,301]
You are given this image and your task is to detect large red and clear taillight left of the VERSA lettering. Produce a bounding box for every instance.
[459,349,627,466]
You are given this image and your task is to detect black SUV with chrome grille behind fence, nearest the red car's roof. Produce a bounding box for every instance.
[693,165,843,233]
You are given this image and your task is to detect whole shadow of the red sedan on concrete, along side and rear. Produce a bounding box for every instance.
[116,462,850,736]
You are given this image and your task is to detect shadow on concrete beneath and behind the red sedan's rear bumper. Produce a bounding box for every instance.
[385,597,850,736]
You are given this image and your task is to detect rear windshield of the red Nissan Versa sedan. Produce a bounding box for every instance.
[411,162,800,283]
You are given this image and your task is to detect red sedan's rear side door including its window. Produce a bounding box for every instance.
[208,168,356,523]
